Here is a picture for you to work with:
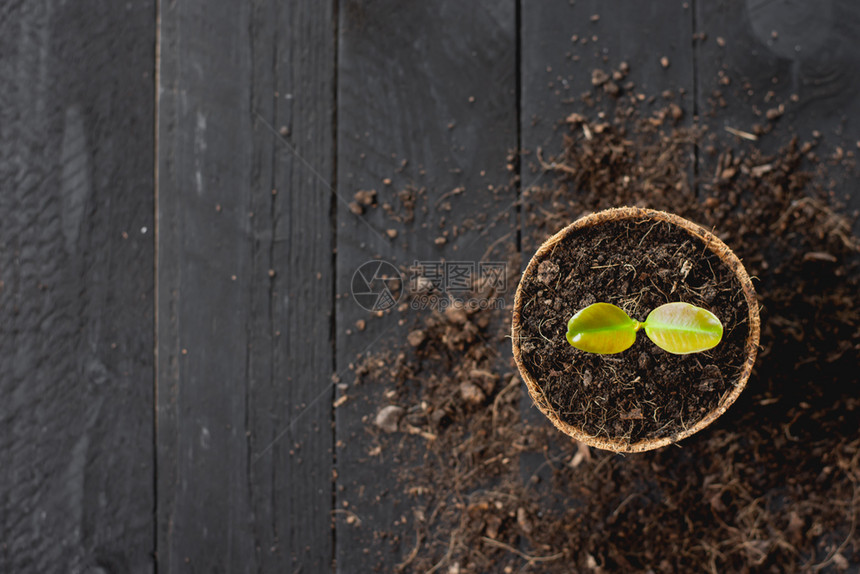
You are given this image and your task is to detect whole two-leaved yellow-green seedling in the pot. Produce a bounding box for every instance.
[567,303,723,355]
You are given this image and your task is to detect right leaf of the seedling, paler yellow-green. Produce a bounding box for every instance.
[642,303,723,355]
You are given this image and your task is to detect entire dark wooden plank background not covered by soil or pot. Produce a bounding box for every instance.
[0,0,860,573]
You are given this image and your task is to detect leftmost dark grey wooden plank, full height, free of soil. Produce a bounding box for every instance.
[0,1,155,573]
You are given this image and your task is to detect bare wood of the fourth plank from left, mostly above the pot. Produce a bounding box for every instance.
[520,0,694,472]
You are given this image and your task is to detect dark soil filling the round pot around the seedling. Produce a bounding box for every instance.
[520,219,749,444]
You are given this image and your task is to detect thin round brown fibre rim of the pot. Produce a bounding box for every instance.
[511,207,761,452]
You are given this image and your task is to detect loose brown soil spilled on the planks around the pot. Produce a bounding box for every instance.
[344,58,860,574]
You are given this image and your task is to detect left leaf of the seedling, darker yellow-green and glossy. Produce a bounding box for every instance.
[567,303,640,355]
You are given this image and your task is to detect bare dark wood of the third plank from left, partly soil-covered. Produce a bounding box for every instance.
[336,0,517,572]
